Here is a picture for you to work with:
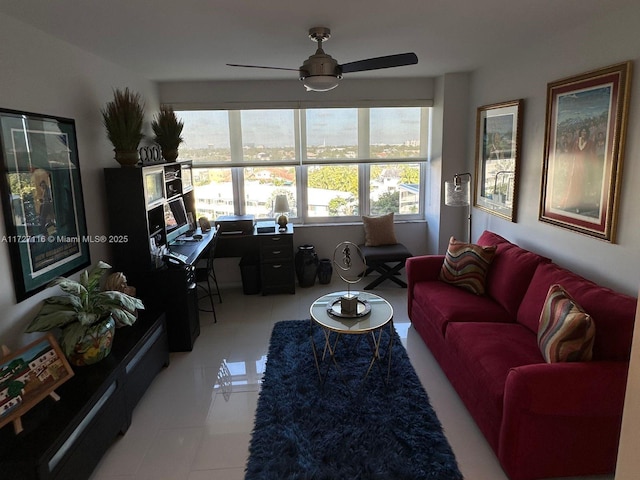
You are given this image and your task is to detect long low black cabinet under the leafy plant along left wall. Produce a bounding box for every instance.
[0,310,169,480]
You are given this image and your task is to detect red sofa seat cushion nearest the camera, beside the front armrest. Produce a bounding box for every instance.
[446,322,544,444]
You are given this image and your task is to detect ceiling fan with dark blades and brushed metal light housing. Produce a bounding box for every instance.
[227,27,418,92]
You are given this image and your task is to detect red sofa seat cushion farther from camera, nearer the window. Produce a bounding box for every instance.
[412,280,514,336]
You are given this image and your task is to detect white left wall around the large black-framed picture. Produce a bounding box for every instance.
[0,14,158,349]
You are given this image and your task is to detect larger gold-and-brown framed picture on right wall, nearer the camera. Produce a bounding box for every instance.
[539,62,632,242]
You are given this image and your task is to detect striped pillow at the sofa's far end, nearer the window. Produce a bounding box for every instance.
[440,237,497,295]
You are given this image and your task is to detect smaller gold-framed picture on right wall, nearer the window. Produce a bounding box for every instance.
[473,99,524,222]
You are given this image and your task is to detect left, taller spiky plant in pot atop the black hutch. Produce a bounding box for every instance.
[101,88,144,166]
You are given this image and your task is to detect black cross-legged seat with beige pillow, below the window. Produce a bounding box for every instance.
[358,213,413,290]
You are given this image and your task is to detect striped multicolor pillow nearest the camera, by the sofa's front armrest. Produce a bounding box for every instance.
[538,284,596,363]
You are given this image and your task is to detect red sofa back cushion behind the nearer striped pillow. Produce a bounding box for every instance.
[517,263,637,361]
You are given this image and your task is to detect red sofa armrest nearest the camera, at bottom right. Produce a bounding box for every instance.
[498,362,629,480]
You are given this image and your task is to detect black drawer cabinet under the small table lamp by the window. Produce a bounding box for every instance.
[257,225,296,295]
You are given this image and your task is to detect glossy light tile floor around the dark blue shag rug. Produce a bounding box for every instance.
[91,280,613,480]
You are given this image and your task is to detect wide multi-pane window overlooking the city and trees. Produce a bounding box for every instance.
[178,107,429,223]
